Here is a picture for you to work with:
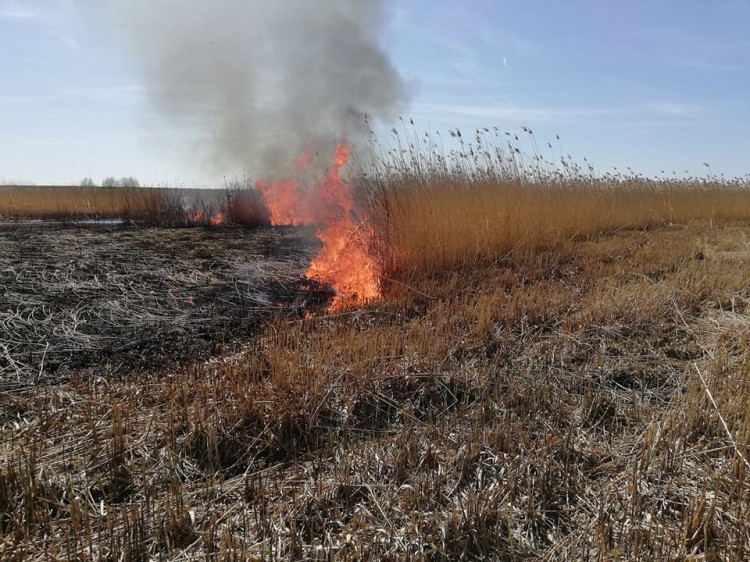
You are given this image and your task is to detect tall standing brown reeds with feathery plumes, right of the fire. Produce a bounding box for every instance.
[355,127,750,281]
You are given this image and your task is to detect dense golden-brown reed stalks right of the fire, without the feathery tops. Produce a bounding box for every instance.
[373,177,750,277]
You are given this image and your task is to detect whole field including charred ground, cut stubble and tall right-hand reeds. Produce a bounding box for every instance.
[0,174,750,561]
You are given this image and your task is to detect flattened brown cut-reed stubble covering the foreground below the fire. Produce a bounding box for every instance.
[0,217,750,560]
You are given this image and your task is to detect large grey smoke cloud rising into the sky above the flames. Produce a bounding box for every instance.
[99,0,406,177]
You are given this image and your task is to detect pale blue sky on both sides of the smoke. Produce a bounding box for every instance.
[0,0,750,186]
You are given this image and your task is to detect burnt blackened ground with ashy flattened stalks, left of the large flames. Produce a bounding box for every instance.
[0,225,325,384]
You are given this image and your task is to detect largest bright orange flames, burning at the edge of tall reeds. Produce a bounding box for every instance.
[256,144,380,312]
